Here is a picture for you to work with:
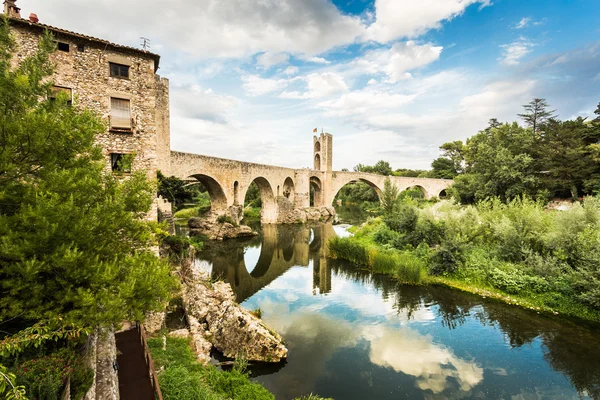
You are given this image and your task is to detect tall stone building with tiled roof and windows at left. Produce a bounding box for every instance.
[4,0,170,177]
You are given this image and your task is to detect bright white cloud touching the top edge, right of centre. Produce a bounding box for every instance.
[363,0,491,43]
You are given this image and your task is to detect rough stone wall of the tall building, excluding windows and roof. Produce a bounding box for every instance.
[11,19,170,178]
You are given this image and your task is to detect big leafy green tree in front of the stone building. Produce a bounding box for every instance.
[0,19,176,328]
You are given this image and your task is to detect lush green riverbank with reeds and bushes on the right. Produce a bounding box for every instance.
[329,198,600,323]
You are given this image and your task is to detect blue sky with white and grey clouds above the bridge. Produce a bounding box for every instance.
[18,0,600,170]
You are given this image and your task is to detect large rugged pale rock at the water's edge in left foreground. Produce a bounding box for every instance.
[183,271,288,362]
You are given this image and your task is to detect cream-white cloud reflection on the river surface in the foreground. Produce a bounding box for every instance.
[367,326,483,394]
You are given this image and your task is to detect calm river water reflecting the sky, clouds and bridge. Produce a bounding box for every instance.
[197,223,600,400]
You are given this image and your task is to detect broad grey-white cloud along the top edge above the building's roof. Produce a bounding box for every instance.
[23,0,364,58]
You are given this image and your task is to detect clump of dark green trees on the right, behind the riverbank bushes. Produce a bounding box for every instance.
[446,99,600,204]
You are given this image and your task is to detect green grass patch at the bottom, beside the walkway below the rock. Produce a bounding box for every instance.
[148,337,274,400]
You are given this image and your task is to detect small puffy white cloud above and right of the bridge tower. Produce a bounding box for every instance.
[352,40,443,83]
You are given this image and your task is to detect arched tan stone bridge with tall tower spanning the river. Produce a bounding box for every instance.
[169,134,452,223]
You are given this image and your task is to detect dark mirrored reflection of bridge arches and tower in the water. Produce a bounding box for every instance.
[209,224,335,303]
